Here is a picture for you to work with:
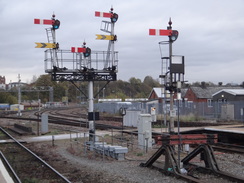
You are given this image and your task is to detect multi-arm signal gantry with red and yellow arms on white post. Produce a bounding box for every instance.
[34,8,118,141]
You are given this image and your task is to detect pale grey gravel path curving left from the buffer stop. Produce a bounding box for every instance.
[59,149,182,183]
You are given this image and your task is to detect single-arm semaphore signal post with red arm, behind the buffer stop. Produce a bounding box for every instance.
[149,19,185,133]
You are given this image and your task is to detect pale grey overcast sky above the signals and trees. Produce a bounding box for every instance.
[0,0,244,84]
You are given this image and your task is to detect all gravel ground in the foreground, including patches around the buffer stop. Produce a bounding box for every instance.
[27,134,244,183]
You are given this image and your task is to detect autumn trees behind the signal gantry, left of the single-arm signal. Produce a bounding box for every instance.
[26,74,160,102]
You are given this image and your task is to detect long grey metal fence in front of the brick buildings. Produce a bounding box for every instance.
[95,101,244,122]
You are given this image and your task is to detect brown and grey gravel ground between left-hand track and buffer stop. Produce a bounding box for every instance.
[29,141,184,183]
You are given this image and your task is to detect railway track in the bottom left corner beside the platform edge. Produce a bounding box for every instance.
[0,127,70,183]
